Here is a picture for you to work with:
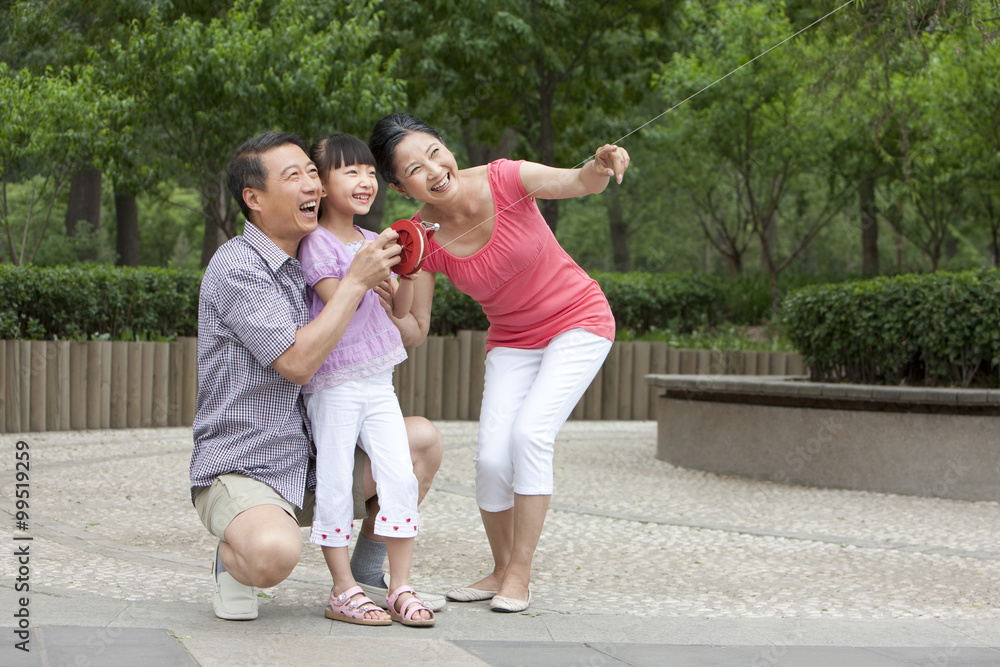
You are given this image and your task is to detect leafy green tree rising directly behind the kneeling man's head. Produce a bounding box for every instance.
[112,0,403,265]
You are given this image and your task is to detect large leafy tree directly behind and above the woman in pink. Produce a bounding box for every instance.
[387,0,677,237]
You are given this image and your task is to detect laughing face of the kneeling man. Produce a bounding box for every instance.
[243,144,320,257]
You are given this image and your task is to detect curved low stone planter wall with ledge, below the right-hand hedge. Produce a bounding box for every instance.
[646,375,1000,501]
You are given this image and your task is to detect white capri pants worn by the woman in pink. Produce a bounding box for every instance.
[476,329,611,512]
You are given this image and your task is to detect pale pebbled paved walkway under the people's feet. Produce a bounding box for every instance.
[0,422,1000,667]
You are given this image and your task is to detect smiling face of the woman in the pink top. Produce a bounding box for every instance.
[393,132,458,204]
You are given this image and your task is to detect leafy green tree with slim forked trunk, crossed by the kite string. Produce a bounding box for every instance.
[656,0,844,311]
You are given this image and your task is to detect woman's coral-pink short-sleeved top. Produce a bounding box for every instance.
[413,160,615,351]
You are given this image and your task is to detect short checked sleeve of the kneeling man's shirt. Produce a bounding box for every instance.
[216,266,299,366]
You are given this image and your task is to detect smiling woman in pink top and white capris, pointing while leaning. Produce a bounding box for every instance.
[369,114,629,612]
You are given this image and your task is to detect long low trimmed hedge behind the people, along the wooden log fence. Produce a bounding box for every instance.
[0,264,726,340]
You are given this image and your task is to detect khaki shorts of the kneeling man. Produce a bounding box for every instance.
[193,447,368,540]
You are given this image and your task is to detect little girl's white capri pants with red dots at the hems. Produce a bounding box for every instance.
[305,368,420,547]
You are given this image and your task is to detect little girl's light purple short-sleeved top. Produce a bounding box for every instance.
[299,226,406,394]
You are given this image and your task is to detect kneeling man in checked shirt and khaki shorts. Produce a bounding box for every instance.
[190,132,441,620]
